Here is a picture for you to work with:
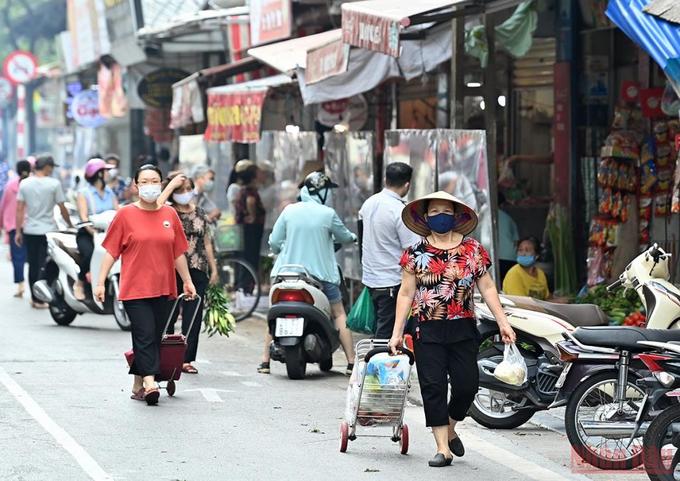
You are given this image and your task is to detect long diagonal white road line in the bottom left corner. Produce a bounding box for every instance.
[0,367,113,481]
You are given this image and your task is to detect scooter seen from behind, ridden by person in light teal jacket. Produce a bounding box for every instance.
[267,264,340,379]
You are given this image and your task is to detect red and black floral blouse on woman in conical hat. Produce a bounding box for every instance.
[400,238,491,323]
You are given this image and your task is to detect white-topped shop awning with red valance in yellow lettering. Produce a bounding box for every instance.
[205,75,293,143]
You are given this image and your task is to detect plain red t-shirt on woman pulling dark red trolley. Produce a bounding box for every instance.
[103,205,188,301]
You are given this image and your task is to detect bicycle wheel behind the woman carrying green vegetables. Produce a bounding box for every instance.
[220,258,262,322]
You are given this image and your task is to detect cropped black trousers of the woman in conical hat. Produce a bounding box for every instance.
[413,339,479,427]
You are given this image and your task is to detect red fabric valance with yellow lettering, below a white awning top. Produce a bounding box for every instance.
[205,89,268,143]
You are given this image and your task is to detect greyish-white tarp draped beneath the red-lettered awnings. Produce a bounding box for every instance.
[297,24,452,105]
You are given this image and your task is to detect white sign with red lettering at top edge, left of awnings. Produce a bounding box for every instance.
[250,0,292,45]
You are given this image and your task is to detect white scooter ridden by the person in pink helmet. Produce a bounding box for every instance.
[33,211,130,331]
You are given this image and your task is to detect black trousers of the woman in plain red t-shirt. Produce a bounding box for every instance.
[123,296,172,376]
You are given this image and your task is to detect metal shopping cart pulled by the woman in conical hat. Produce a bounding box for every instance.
[340,339,415,454]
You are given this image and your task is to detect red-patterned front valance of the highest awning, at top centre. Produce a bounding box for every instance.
[342,5,408,57]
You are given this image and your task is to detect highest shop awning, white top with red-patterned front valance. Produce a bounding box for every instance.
[342,0,469,57]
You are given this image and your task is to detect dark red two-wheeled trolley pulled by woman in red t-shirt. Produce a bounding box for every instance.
[125,294,203,396]
